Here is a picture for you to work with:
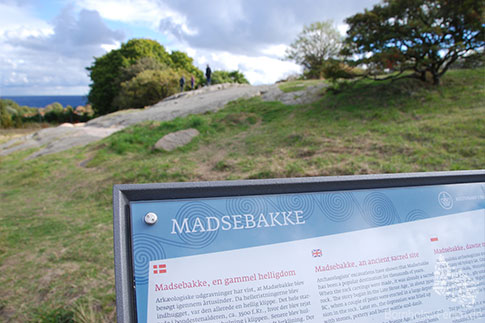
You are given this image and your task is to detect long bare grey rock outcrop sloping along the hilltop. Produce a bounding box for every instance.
[0,84,323,159]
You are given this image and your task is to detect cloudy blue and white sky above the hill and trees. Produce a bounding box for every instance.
[0,0,379,96]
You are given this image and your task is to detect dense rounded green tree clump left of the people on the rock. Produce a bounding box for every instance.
[87,39,204,115]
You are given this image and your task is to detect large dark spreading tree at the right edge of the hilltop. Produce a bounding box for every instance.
[343,0,485,84]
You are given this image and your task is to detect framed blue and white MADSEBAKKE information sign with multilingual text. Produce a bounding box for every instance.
[114,171,485,323]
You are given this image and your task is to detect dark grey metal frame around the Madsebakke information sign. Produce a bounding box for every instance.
[113,170,485,322]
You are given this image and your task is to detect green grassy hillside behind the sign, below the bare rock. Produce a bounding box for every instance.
[0,69,485,322]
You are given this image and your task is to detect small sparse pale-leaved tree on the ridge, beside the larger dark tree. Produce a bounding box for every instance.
[286,21,342,78]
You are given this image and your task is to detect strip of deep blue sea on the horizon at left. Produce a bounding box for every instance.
[0,95,88,108]
